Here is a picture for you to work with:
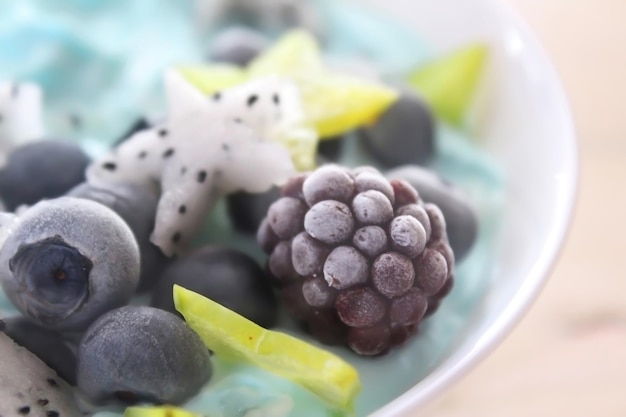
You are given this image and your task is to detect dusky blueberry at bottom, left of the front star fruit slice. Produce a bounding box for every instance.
[78,306,212,405]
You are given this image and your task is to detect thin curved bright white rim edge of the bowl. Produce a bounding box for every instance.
[370,0,580,417]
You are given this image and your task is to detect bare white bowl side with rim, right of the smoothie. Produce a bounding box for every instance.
[368,0,578,417]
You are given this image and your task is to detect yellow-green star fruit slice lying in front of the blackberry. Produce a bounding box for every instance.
[174,285,361,410]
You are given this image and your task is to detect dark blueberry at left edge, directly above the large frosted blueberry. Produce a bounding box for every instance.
[0,140,90,211]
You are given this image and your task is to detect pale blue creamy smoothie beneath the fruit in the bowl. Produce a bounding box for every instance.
[0,0,505,417]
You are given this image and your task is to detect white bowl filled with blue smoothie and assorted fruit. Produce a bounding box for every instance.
[0,0,575,417]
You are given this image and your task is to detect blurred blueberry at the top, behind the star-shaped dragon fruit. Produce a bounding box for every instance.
[209,27,269,67]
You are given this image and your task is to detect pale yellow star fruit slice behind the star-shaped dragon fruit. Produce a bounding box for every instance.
[181,30,398,139]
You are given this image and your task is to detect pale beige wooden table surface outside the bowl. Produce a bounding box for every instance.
[416,0,626,417]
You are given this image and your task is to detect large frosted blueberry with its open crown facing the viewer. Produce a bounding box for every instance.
[0,197,139,331]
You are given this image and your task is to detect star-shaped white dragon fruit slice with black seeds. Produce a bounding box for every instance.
[87,71,297,256]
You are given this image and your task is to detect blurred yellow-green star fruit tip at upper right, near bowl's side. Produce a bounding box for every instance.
[409,44,488,127]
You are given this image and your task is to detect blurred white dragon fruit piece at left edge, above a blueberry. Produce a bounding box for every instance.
[0,82,44,163]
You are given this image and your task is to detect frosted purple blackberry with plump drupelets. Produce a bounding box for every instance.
[257,165,454,356]
